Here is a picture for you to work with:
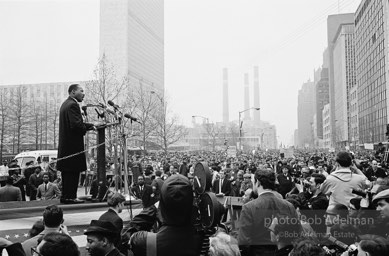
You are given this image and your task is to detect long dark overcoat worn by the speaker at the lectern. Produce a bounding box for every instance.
[57,97,93,173]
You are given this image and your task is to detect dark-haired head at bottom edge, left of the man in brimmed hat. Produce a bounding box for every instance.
[37,232,80,256]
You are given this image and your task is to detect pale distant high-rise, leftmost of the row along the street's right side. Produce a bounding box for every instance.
[297,81,316,147]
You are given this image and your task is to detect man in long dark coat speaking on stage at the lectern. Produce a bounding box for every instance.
[57,84,96,203]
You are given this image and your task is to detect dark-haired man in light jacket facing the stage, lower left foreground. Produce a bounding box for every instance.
[22,205,69,256]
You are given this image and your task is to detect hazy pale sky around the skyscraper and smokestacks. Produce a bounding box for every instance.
[0,0,360,144]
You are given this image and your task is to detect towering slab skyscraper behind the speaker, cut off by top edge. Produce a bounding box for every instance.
[100,0,164,93]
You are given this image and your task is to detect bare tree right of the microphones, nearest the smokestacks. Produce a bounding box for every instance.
[155,98,188,155]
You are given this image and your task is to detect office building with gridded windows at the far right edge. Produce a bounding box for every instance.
[354,0,389,144]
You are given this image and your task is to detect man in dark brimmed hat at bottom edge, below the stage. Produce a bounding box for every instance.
[84,220,124,256]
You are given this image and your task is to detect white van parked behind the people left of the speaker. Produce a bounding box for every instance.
[14,150,58,170]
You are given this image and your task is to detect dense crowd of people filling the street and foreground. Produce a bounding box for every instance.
[0,150,389,256]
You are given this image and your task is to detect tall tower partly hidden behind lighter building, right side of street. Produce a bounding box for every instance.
[327,13,354,147]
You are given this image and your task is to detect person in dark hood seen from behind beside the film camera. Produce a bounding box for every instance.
[129,174,202,256]
